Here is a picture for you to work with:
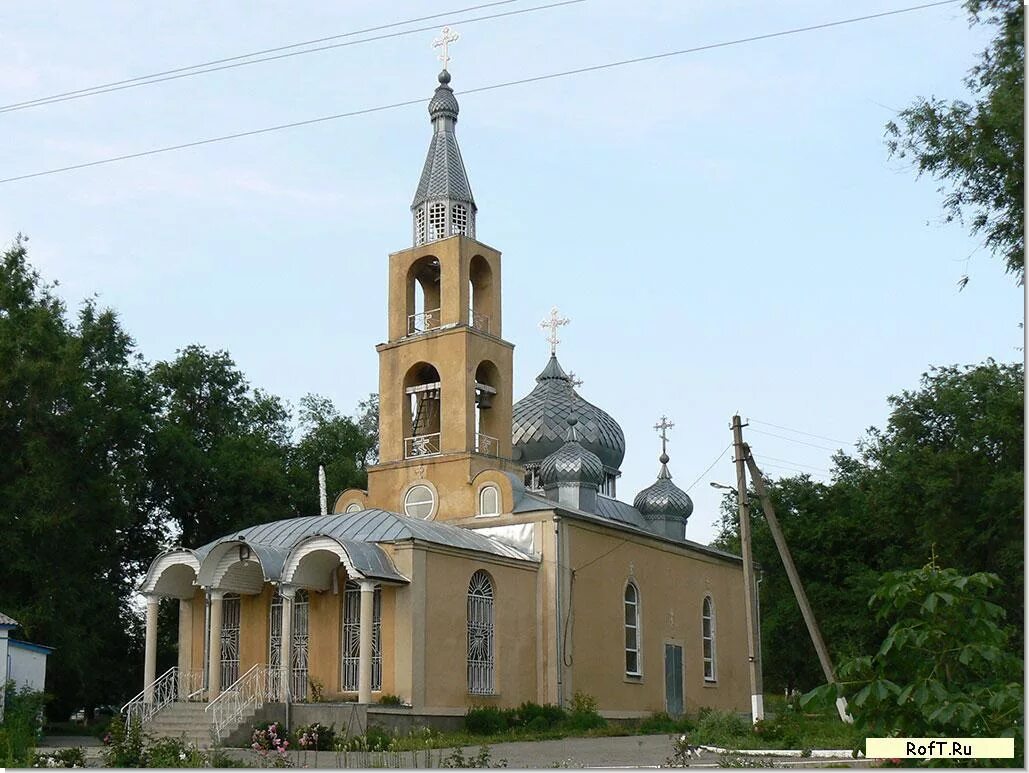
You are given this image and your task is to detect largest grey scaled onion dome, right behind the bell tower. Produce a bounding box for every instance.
[511,354,626,470]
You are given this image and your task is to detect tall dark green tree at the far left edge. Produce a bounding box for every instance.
[0,239,159,715]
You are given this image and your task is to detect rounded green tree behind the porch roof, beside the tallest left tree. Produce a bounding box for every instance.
[149,345,292,547]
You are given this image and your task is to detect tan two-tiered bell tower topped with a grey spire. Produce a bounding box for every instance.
[367,54,521,520]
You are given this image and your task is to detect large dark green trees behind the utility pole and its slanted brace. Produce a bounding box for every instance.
[715,360,1025,690]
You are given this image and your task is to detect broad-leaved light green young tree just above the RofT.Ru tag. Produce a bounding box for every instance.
[802,561,1025,767]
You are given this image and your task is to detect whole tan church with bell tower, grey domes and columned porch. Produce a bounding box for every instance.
[132,48,750,736]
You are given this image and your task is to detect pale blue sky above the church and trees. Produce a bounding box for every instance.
[0,0,1023,542]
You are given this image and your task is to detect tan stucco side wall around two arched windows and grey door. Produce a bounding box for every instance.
[563,519,750,711]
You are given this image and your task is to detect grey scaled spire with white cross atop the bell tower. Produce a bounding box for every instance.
[411,27,477,247]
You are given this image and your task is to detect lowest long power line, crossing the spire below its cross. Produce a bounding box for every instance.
[0,0,959,186]
